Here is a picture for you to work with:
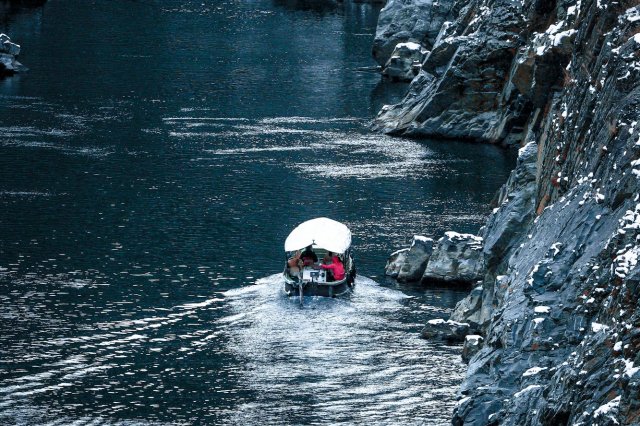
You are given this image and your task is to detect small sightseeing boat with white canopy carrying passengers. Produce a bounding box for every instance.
[283,217,356,303]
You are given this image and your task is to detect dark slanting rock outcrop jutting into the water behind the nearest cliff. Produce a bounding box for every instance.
[374,0,577,145]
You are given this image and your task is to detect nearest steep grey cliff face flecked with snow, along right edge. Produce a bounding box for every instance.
[444,0,640,425]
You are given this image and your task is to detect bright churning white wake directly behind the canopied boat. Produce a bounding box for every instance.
[220,274,464,424]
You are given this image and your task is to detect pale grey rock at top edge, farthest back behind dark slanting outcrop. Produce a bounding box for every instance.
[373,0,459,66]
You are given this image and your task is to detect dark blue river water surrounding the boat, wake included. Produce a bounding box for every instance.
[0,0,513,425]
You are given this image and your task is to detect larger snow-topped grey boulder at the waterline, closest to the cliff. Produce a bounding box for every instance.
[422,231,484,283]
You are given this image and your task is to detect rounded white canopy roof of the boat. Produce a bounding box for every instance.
[284,217,351,253]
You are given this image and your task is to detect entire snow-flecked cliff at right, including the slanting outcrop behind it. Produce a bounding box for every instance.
[376,0,640,425]
